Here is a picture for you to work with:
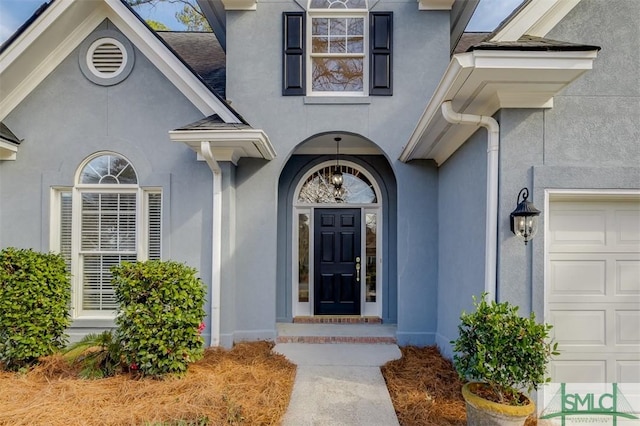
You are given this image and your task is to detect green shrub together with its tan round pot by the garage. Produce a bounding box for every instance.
[451,293,558,426]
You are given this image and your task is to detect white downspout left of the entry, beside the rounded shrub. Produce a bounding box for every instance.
[200,141,222,346]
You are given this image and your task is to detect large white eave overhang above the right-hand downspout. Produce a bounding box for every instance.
[400,48,598,165]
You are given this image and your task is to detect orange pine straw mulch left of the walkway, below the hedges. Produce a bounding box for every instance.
[0,342,296,426]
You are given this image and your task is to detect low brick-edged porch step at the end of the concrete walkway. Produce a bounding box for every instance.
[276,323,397,345]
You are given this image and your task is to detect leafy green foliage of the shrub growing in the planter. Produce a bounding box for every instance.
[451,293,558,405]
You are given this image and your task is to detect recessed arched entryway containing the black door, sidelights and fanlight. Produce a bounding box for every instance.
[276,133,397,323]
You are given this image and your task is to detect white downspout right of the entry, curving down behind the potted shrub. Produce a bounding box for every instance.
[442,101,500,300]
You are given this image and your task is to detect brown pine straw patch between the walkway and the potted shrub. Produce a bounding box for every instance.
[382,346,536,426]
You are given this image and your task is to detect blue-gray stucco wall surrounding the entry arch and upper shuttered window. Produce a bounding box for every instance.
[227,0,450,344]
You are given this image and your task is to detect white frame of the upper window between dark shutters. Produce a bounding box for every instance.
[305,9,369,97]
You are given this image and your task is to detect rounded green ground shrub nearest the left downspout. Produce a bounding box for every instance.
[112,260,205,377]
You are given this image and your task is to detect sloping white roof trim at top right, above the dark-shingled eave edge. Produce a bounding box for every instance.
[490,0,580,42]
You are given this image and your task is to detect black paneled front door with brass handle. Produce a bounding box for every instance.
[313,209,361,315]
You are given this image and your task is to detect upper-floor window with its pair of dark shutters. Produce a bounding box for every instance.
[283,7,393,96]
